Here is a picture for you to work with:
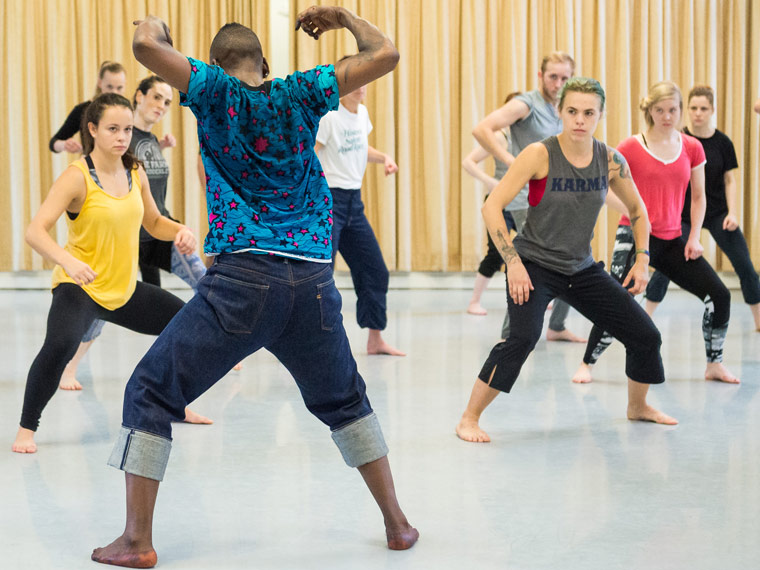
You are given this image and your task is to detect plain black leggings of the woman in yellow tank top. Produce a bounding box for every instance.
[21,281,185,431]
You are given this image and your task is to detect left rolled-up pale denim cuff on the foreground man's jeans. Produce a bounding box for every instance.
[108,426,172,481]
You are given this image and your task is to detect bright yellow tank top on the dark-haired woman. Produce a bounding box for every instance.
[53,159,143,311]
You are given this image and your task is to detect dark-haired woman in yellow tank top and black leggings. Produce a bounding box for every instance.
[13,93,208,453]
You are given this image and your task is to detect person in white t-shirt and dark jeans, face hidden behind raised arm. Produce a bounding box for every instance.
[314,82,406,356]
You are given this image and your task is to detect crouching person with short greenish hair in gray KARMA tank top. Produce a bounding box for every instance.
[456,77,678,442]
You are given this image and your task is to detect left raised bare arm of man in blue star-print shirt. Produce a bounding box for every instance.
[132,16,190,93]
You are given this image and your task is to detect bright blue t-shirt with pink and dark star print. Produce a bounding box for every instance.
[180,58,338,263]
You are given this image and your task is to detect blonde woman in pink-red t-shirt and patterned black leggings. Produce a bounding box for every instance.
[573,81,739,384]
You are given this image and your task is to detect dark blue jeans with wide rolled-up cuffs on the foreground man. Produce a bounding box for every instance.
[109,253,388,480]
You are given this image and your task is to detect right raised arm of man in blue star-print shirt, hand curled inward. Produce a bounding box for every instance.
[296,6,399,96]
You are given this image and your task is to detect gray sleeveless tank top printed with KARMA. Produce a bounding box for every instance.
[514,136,609,275]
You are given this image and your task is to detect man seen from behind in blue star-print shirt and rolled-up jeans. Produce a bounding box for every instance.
[92,6,419,568]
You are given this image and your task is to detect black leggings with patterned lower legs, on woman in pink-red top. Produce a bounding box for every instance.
[583,225,731,364]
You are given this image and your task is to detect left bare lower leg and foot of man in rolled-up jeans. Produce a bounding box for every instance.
[92,473,159,568]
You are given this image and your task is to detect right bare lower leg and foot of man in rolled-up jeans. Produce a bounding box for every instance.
[358,456,420,550]
